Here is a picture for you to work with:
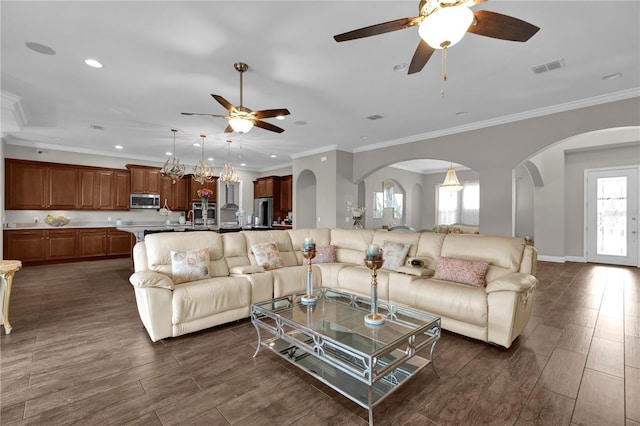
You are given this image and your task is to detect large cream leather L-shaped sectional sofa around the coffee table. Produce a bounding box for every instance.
[130,228,537,348]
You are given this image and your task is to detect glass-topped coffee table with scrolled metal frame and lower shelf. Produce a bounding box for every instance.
[251,288,441,425]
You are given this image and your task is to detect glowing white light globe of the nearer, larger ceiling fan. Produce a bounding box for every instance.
[418,6,473,49]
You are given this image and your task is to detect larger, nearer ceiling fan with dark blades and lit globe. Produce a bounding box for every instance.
[333,0,540,74]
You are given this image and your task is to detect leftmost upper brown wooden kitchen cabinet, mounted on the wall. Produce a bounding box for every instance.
[5,159,78,210]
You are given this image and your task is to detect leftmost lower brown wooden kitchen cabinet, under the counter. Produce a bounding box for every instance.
[3,229,78,263]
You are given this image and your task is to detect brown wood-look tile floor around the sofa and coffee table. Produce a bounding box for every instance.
[0,260,640,426]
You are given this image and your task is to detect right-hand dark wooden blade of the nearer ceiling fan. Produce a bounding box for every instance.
[467,10,540,41]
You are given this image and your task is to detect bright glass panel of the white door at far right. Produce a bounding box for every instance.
[596,176,627,256]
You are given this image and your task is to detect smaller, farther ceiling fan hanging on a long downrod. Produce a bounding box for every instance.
[182,62,290,133]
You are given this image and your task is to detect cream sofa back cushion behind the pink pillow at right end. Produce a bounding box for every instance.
[441,234,525,282]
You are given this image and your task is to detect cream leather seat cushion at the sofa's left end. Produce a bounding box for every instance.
[171,277,251,324]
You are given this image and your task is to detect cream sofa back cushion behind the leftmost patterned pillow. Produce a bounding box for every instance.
[144,231,229,278]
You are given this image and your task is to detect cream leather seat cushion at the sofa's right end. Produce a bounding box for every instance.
[409,279,487,327]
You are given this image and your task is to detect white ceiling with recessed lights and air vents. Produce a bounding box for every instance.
[0,0,640,171]
